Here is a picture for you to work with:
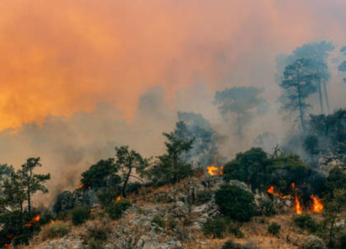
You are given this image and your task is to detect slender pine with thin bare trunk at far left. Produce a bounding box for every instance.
[18,157,50,212]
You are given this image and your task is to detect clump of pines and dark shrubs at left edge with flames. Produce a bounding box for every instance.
[0,158,50,245]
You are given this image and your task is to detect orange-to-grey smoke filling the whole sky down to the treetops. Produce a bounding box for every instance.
[0,0,346,202]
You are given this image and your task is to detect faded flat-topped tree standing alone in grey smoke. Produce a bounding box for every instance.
[214,87,268,147]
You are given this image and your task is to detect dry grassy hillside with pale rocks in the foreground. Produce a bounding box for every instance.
[26,176,318,249]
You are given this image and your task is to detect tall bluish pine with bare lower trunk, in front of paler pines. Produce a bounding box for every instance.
[280,59,317,132]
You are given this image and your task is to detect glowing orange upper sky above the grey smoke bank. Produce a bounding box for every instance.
[0,0,346,130]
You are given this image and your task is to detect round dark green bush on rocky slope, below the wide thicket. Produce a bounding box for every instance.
[215,185,255,222]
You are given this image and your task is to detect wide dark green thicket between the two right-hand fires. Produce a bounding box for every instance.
[223,148,313,194]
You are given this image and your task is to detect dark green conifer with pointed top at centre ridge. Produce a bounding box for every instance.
[147,132,194,184]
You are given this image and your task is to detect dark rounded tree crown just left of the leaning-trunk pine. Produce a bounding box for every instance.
[81,158,121,188]
